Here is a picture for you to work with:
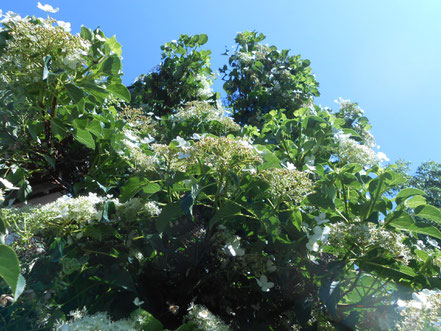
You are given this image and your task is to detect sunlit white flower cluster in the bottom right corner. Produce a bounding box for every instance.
[395,289,441,331]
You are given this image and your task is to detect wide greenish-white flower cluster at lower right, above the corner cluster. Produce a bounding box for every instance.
[327,220,412,264]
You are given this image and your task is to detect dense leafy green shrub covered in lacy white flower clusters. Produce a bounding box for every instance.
[0,4,441,331]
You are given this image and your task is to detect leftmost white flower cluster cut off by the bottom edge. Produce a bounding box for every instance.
[54,310,137,331]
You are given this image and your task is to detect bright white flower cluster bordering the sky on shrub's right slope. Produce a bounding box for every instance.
[335,133,389,166]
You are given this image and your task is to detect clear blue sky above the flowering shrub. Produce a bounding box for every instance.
[0,0,441,168]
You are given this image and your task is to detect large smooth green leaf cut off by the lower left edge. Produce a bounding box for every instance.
[0,245,26,300]
